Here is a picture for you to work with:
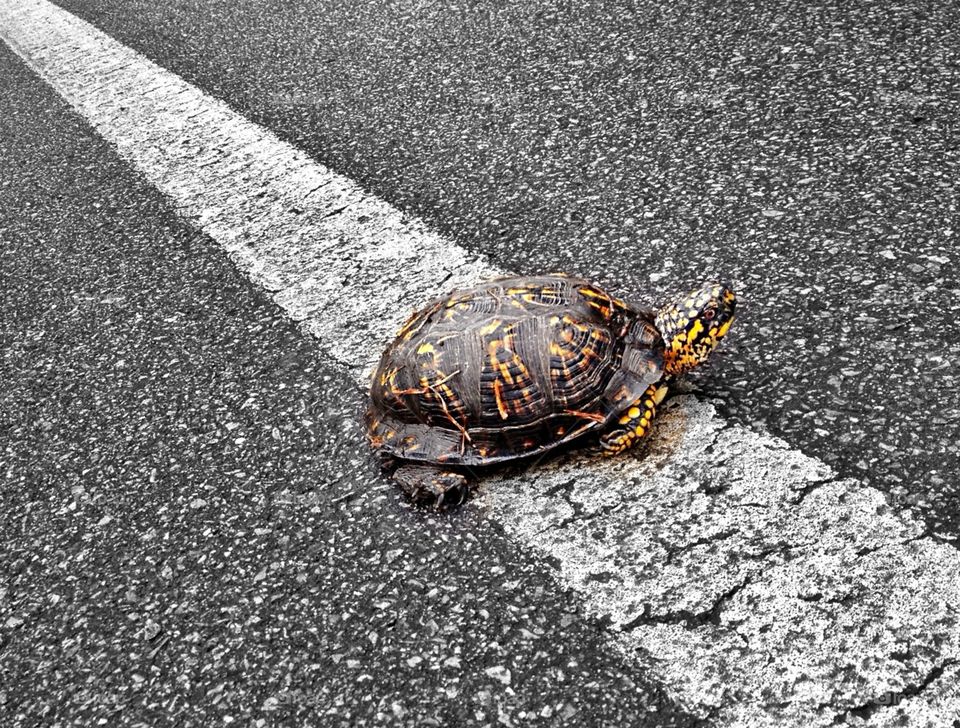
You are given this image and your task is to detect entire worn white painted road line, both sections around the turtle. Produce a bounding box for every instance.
[0,0,960,726]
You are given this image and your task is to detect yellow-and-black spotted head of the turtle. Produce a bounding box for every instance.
[656,283,737,375]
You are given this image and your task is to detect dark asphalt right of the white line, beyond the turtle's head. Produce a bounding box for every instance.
[50,0,960,537]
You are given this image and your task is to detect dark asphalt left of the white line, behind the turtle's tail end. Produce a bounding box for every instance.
[0,47,696,726]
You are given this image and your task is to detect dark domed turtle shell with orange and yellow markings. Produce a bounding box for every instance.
[367,275,664,465]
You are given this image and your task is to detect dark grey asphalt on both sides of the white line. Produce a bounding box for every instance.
[0,3,960,725]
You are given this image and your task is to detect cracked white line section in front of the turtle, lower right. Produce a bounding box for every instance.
[485,396,960,726]
